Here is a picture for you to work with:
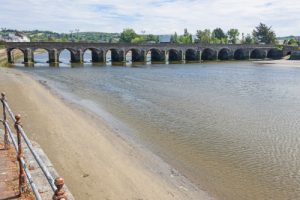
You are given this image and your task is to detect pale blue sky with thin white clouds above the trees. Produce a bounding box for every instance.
[0,0,300,36]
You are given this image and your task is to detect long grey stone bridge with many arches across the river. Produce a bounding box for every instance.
[6,42,283,63]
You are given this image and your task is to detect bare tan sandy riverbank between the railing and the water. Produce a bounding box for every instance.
[0,68,211,199]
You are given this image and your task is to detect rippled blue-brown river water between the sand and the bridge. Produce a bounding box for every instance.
[14,52,300,200]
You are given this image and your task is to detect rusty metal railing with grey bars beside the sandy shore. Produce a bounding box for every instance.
[0,93,67,200]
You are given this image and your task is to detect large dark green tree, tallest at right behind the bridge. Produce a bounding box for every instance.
[252,23,276,44]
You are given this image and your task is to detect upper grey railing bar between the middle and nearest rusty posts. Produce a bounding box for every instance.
[18,125,57,192]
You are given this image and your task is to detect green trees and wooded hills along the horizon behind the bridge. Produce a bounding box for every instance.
[0,23,300,45]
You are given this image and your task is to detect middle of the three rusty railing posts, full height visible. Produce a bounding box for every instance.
[15,114,26,195]
